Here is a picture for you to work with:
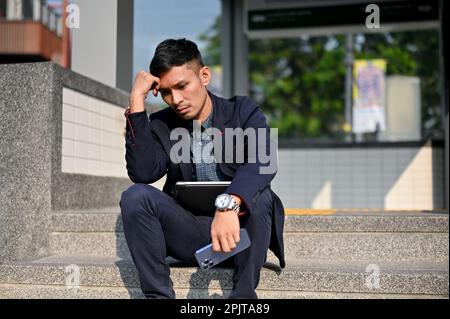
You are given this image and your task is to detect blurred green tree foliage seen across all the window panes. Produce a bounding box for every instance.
[201,17,442,140]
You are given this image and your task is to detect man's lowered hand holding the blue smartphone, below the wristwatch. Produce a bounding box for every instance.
[211,195,241,253]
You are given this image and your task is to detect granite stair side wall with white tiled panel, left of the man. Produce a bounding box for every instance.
[0,63,131,262]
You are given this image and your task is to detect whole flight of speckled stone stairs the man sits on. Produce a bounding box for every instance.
[0,207,449,298]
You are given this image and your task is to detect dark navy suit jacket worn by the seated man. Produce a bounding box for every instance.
[126,92,285,268]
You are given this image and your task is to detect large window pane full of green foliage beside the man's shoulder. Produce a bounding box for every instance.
[249,36,345,140]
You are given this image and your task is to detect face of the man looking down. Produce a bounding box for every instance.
[159,62,210,120]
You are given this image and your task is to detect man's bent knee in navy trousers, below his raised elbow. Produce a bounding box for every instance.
[120,183,161,219]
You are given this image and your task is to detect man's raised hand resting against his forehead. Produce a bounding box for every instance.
[130,71,159,113]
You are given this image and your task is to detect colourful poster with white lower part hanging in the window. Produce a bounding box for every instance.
[352,59,386,133]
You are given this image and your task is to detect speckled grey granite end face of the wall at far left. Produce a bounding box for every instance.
[0,64,56,263]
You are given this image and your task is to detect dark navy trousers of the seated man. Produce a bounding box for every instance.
[120,184,272,298]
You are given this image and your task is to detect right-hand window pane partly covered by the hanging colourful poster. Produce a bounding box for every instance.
[355,30,444,141]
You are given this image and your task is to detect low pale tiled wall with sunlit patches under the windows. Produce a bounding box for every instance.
[272,143,445,210]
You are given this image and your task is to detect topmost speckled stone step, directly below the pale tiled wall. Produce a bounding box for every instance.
[52,207,449,233]
